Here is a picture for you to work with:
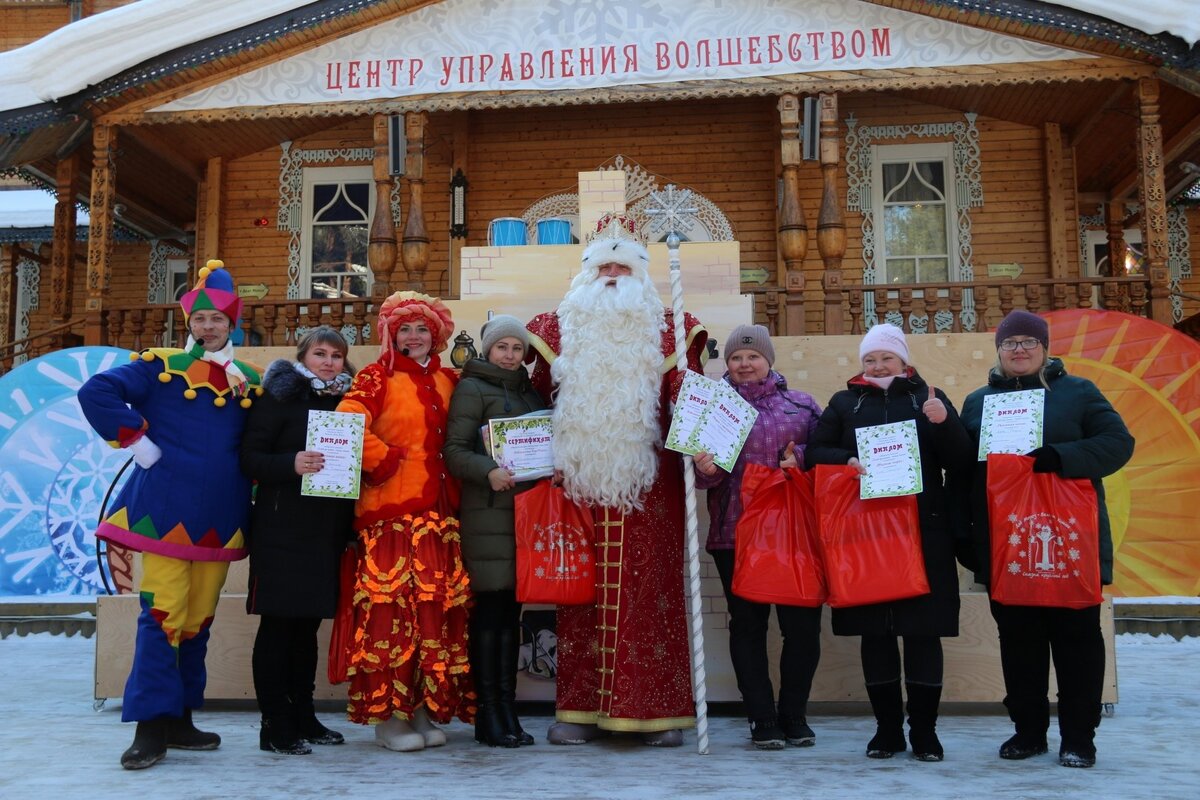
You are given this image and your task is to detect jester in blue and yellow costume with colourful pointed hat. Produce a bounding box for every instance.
[79,260,262,769]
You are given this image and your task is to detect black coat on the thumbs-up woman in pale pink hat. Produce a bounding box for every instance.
[804,367,971,636]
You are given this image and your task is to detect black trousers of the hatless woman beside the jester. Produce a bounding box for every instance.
[251,615,320,717]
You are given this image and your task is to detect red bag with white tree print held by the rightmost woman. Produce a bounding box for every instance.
[988,453,1104,608]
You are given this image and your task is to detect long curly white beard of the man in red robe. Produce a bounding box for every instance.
[551,276,664,511]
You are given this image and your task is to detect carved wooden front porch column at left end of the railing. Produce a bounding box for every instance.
[84,125,116,345]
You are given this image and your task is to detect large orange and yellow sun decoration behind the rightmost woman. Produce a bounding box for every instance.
[1044,309,1200,597]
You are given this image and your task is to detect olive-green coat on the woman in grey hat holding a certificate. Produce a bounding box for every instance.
[442,359,545,591]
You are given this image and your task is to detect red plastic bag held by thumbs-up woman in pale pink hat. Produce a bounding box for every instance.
[814,464,929,608]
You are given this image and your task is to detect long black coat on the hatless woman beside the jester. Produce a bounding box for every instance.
[241,360,354,619]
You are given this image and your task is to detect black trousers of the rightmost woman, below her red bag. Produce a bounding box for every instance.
[991,601,1104,748]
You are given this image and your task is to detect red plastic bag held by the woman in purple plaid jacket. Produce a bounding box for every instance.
[733,464,828,608]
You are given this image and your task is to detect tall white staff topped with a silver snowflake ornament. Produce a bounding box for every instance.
[646,184,708,756]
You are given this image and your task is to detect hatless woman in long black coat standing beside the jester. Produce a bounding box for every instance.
[241,326,354,754]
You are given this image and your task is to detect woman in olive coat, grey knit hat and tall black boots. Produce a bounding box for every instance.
[442,314,545,747]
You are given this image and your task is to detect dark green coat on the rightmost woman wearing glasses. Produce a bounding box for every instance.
[949,359,1134,584]
